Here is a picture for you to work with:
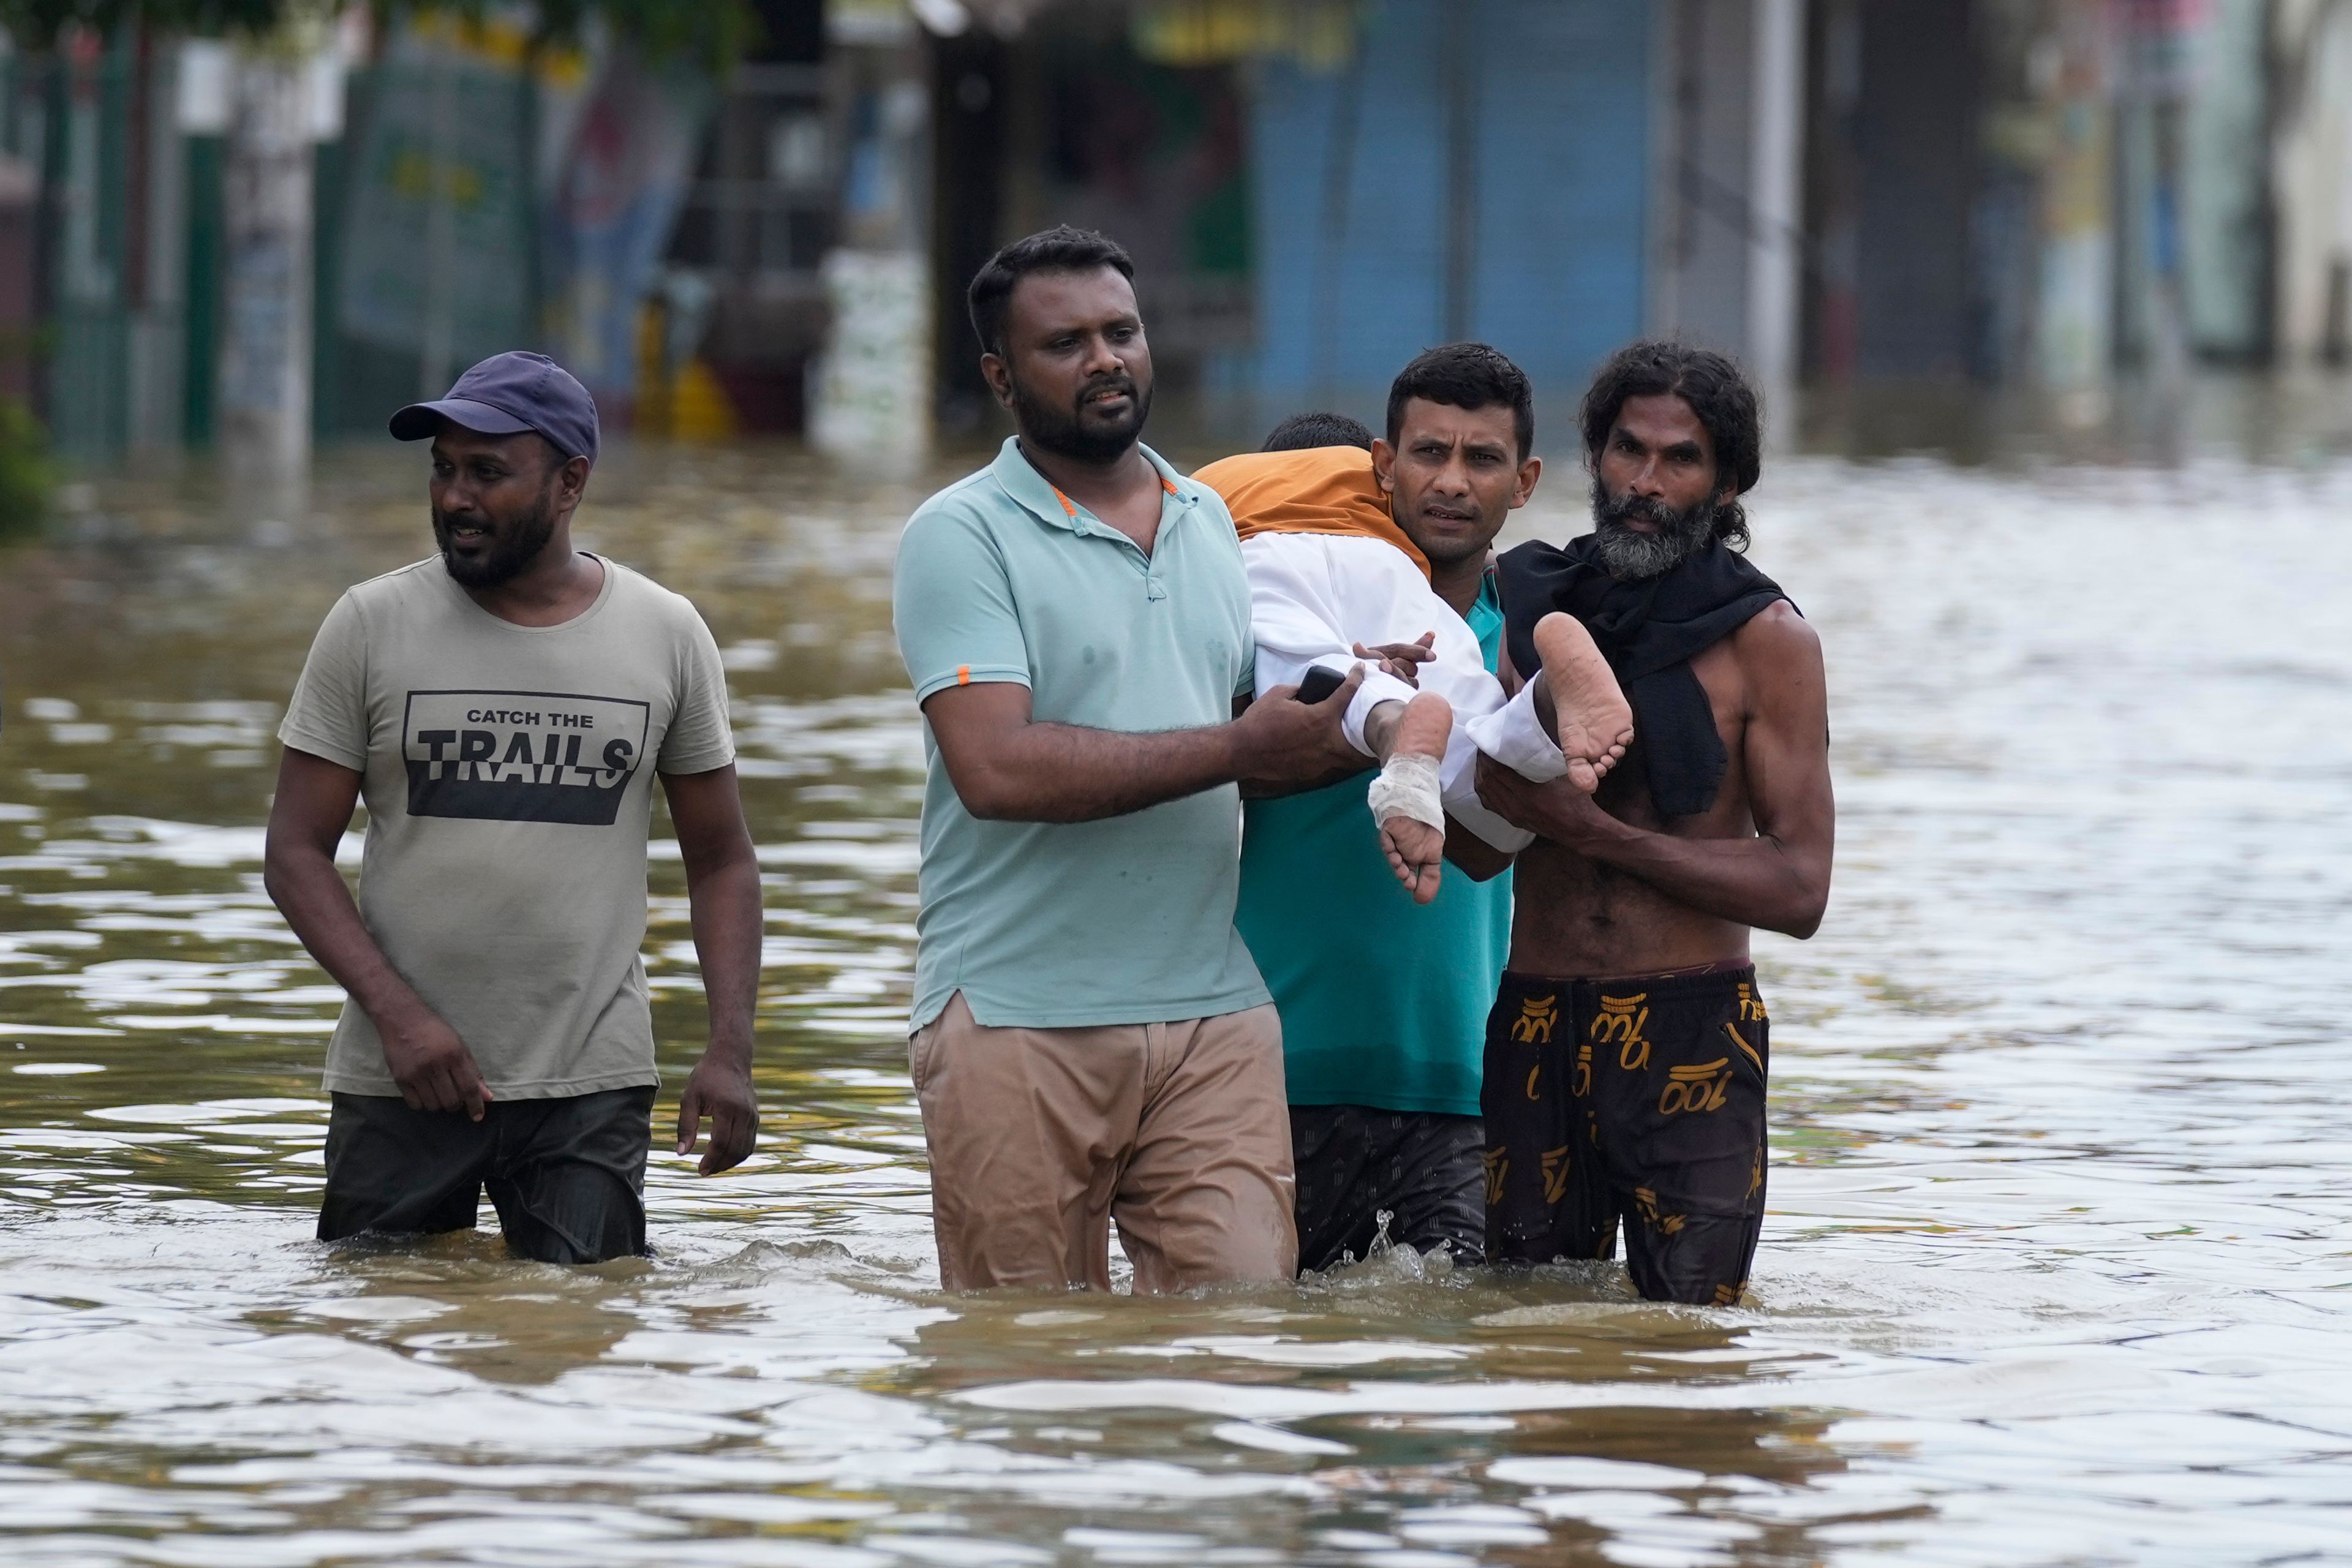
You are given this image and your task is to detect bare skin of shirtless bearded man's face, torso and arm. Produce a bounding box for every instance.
[1479,395,1837,978]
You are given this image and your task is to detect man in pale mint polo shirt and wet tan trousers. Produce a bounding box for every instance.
[891,228,1364,1291]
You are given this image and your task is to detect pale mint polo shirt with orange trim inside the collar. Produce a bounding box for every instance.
[891,440,1268,1030]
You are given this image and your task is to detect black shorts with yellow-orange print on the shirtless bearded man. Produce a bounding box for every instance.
[1479,968,1771,1307]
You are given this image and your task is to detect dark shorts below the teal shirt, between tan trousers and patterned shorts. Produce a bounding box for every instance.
[1291,1105,1487,1270]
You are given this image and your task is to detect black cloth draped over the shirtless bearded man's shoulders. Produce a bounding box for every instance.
[1496,533,1797,816]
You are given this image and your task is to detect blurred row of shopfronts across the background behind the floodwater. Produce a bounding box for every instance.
[13,0,2352,461]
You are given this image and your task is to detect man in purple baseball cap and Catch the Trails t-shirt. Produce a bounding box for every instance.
[266,353,760,1262]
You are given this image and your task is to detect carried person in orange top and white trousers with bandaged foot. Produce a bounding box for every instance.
[1193,447,1632,903]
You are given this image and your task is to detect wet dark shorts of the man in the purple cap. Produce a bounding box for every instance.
[317,1088,654,1262]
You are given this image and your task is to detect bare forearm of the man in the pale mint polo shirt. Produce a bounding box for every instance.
[957,722,1237,823]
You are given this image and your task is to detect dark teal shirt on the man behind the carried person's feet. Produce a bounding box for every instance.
[1235,576,1510,1117]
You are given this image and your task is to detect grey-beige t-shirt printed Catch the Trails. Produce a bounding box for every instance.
[277,557,734,1100]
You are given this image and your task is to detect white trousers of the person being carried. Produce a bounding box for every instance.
[1242,533,1569,851]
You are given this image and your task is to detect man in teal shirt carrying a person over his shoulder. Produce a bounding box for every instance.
[1235,343,1543,1270]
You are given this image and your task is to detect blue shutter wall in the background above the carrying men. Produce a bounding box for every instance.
[1221,0,1651,435]
